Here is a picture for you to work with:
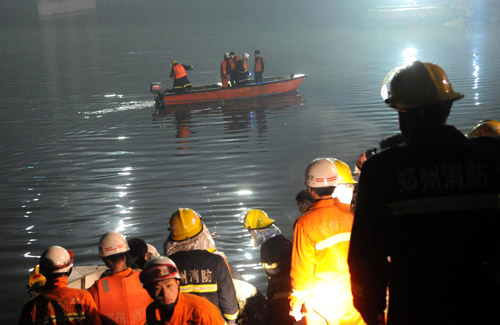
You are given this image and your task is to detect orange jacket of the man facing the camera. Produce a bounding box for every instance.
[146,292,224,325]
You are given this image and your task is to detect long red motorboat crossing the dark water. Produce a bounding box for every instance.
[150,74,307,108]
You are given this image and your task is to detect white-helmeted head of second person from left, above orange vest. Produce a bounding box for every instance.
[98,231,129,273]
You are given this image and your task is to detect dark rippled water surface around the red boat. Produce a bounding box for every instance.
[0,2,500,323]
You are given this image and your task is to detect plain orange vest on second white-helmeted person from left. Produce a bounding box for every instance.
[89,268,153,325]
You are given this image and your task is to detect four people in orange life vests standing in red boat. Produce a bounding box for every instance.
[170,50,265,93]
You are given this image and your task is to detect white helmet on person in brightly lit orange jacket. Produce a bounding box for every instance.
[304,158,339,187]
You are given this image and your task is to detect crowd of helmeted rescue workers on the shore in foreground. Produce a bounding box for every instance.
[19,61,500,325]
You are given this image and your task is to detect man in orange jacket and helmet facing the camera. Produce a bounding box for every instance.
[140,256,224,325]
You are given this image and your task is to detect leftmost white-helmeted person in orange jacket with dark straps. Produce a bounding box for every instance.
[19,246,101,324]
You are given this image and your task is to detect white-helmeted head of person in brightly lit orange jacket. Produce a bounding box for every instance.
[304,158,339,200]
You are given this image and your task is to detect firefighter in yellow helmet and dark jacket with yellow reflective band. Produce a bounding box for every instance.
[166,208,239,324]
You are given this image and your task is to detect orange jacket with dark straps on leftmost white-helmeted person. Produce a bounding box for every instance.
[19,277,101,325]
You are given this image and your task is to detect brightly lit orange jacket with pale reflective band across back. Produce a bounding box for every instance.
[290,198,353,291]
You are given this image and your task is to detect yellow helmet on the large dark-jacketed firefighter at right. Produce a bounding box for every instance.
[380,61,464,111]
